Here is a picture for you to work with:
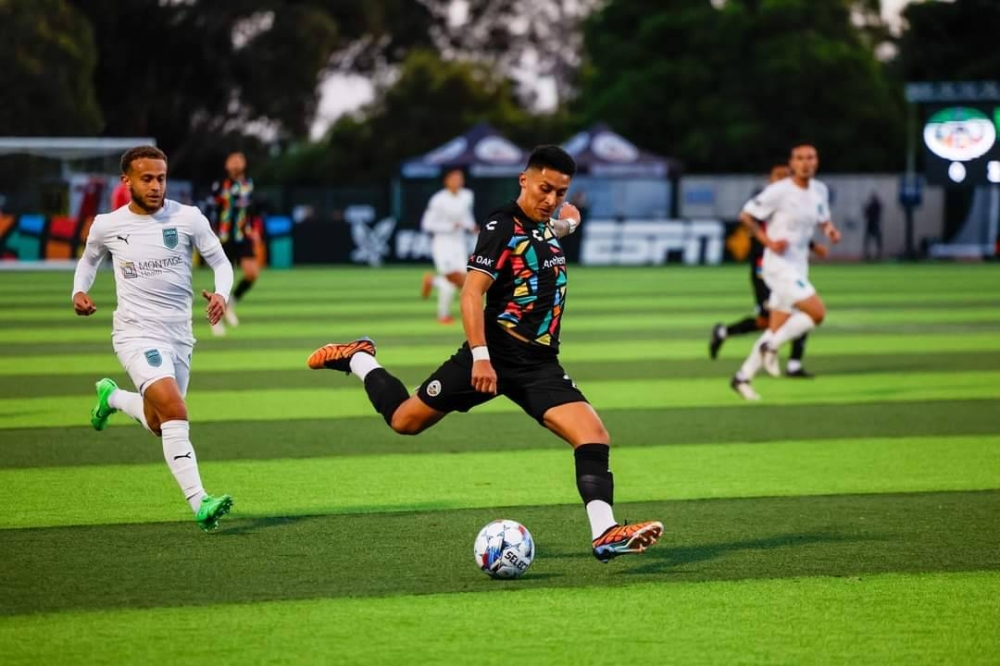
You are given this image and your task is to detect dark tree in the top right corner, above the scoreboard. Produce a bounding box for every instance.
[895,0,1000,81]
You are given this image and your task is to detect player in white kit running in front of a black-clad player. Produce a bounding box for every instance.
[730,144,840,400]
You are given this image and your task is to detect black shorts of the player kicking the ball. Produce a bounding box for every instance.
[417,329,587,425]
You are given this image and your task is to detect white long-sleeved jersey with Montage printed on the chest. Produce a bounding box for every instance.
[73,199,233,340]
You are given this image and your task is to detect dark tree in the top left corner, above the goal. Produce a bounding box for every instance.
[0,0,102,136]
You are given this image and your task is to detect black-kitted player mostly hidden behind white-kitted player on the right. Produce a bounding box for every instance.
[708,164,829,378]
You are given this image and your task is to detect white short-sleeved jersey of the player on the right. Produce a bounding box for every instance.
[743,178,830,275]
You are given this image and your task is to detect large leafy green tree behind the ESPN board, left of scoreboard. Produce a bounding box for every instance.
[577,0,903,172]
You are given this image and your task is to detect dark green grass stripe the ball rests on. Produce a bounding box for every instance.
[0,491,1000,616]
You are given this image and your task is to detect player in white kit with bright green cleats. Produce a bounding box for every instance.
[73,146,233,531]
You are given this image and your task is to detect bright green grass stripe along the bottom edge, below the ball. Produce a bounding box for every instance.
[0,572,1000,666]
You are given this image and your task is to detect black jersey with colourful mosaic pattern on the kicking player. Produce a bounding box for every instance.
[469,202,566,353]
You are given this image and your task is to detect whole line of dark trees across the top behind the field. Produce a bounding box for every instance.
[0,0,1000,183]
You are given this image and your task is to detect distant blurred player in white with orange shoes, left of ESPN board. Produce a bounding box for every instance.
[420,169,476,324]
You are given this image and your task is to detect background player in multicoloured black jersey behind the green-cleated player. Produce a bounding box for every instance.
[212,152,260,335]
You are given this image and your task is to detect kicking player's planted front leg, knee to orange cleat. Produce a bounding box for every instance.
[543,401,663,562]
